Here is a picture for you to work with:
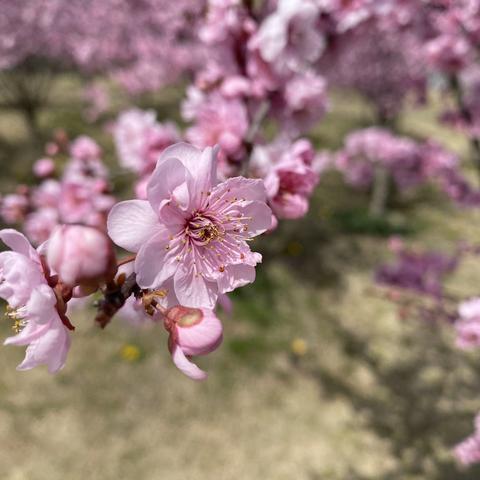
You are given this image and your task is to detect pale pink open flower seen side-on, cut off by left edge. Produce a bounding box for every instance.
[0,229,70,373]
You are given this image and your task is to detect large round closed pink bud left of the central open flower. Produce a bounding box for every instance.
[47,225,116,287]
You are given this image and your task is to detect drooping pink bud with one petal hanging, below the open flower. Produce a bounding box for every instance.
[164,306,223,380]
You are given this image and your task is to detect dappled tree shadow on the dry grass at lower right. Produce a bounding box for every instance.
[299,316,480,480]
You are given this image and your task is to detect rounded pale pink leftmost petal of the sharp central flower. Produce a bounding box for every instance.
[107,200,162,252]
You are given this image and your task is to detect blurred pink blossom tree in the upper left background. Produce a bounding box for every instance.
[0,0,204,135]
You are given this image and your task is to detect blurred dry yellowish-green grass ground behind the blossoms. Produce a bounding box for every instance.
[0,78,480,480]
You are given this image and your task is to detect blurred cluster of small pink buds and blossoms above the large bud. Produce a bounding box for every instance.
[0,134,115,245]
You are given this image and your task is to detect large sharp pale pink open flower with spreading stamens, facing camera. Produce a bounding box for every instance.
[108,143,271,308]
